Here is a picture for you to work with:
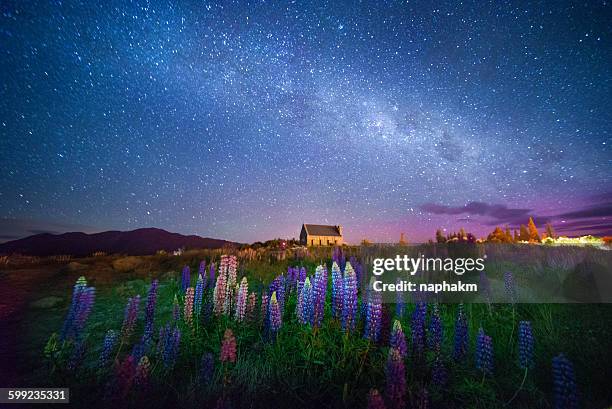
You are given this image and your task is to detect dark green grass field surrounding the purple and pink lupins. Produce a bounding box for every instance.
[0,244,612,408]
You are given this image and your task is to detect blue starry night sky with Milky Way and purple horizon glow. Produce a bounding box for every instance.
[0,0,612,242]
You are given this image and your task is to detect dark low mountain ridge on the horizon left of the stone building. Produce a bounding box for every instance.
[0,228,237,257]
